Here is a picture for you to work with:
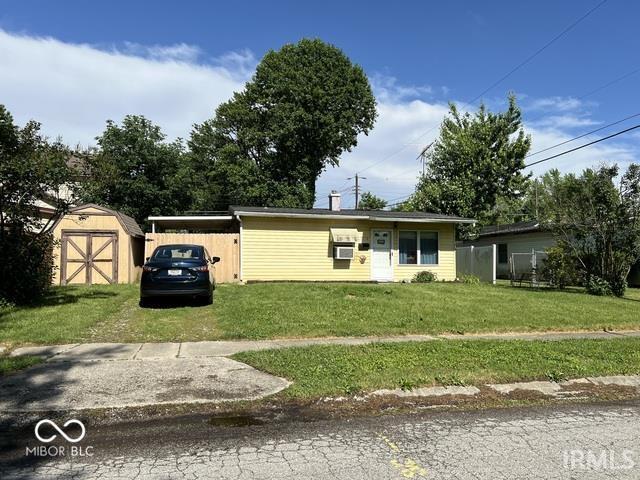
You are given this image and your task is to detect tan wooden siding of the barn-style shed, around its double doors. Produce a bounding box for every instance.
[53,208,141,285]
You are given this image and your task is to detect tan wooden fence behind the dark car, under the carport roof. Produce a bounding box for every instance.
[144,233,240,283]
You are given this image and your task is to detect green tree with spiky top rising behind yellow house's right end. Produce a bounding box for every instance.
[404,95,531,233]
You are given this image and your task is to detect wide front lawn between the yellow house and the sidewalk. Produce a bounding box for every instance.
[0,283,640,346]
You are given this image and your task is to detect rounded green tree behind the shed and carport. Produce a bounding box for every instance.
[81,115,193,229]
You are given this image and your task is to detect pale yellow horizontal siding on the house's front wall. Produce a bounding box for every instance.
[241,217,456,281]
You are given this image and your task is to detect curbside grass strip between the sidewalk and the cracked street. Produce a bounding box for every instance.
[233,338,640,398]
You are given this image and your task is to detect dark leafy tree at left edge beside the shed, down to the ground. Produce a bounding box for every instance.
[0,105,73,303]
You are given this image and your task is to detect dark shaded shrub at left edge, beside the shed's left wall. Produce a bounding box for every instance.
[0,232,53,304]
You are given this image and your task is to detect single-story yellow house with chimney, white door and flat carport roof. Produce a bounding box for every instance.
[147,193,474,282]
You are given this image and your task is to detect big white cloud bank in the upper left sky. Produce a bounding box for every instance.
[0,30,252,145]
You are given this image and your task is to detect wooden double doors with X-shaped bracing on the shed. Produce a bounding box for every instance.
[60,230,118,285]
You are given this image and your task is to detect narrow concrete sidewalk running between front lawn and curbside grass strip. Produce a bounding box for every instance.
[11,330,640,361]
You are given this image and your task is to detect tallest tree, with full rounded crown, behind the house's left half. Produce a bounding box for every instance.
[189,39,376,209]
